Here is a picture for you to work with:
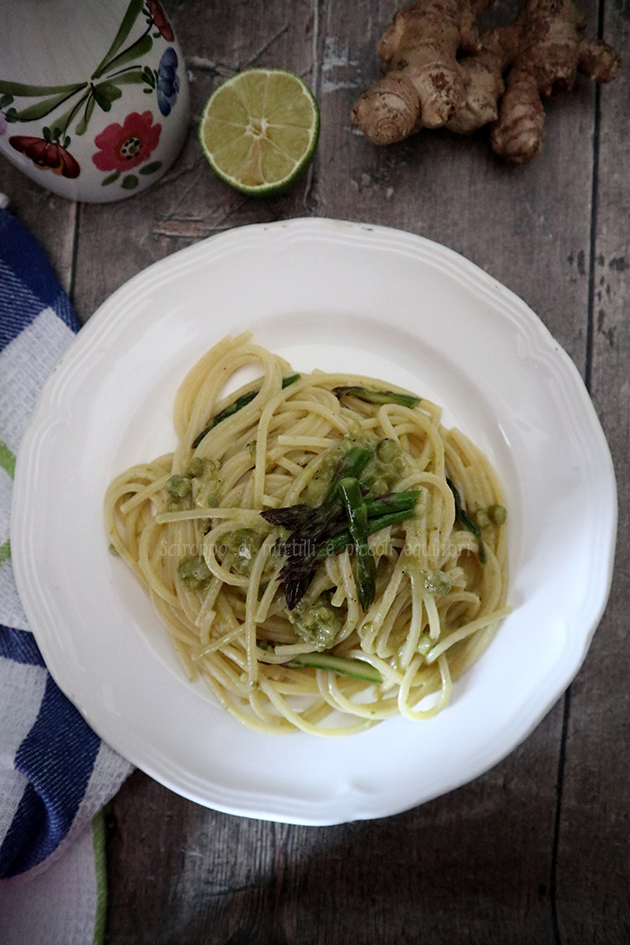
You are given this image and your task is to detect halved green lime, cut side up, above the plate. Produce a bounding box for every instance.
[199,69,319,195]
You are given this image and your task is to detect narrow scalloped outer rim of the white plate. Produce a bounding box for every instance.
[12,218,616,825]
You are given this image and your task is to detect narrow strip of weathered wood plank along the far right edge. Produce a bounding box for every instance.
[557,3,630,945]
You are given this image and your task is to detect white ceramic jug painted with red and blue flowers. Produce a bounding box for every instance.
[0,0,189,202]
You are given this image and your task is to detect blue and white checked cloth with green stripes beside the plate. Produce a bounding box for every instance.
[0,205,131,945]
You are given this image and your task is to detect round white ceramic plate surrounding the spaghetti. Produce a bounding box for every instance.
[12,219,616,824]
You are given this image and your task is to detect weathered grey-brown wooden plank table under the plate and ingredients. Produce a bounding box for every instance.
[0,0,630,945]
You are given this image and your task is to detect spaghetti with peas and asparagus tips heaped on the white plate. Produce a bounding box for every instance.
[105,334,508,735]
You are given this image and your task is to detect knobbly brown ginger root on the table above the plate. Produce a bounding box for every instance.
[352,0,621,163]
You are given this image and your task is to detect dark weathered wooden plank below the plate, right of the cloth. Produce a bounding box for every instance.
[109,710,559,945]
